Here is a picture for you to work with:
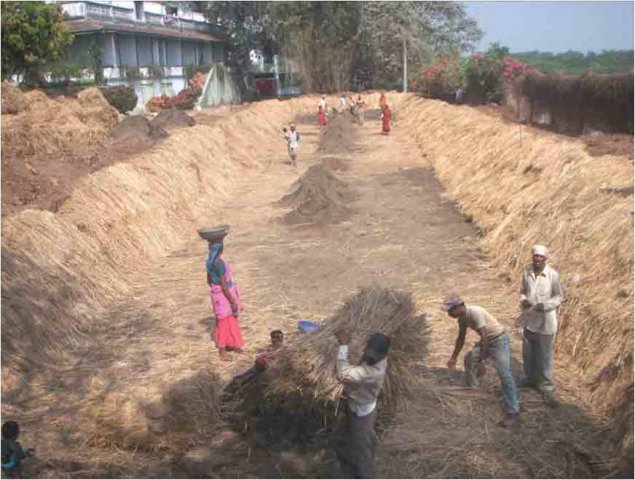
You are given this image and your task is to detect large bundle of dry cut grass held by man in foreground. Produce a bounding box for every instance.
[265,286,427,411]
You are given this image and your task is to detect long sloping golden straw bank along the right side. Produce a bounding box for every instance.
[402,99,633,468]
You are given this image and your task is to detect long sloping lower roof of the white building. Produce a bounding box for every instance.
[66,19,226,42]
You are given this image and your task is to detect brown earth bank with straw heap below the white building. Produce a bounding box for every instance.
[2,82,199,216]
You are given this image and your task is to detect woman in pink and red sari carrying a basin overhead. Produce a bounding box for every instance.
[206,238,245,361]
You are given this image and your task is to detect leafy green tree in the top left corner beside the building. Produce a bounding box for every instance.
[0,2,73,83]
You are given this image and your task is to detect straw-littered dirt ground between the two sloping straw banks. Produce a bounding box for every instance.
[25,104,606,478]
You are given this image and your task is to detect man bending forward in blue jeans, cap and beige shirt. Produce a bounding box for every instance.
[443,295,518,426]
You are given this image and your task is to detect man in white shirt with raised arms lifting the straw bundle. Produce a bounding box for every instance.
[326,330,390,478]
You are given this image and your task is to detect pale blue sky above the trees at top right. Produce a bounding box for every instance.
[466,1,633,53]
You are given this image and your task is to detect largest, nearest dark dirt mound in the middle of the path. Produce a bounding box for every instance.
[279,165,352,225]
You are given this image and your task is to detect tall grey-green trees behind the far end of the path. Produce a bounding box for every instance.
[195,2,482,91]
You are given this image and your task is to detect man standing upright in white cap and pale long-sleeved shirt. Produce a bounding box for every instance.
[519,245,563,404]
